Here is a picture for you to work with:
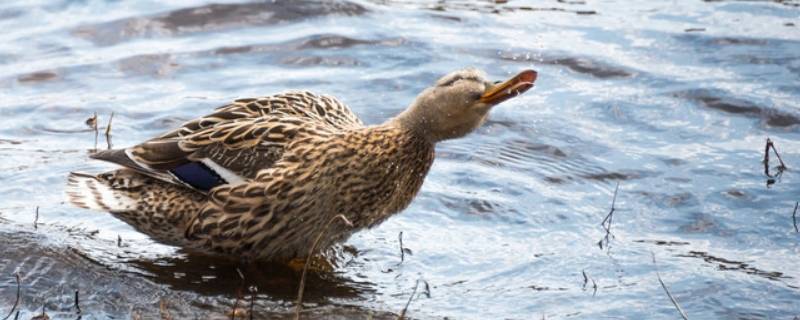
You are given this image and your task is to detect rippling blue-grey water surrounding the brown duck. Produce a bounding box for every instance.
[0,0,800,319]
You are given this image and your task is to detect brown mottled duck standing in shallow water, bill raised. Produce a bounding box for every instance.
[65,68,538,262]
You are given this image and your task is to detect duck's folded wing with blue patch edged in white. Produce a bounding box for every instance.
[92,92,363,192]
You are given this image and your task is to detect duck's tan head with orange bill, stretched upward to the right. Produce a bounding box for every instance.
[393,69,537,142]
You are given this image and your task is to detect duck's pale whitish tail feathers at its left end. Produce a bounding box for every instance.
[66,172,137,212]
